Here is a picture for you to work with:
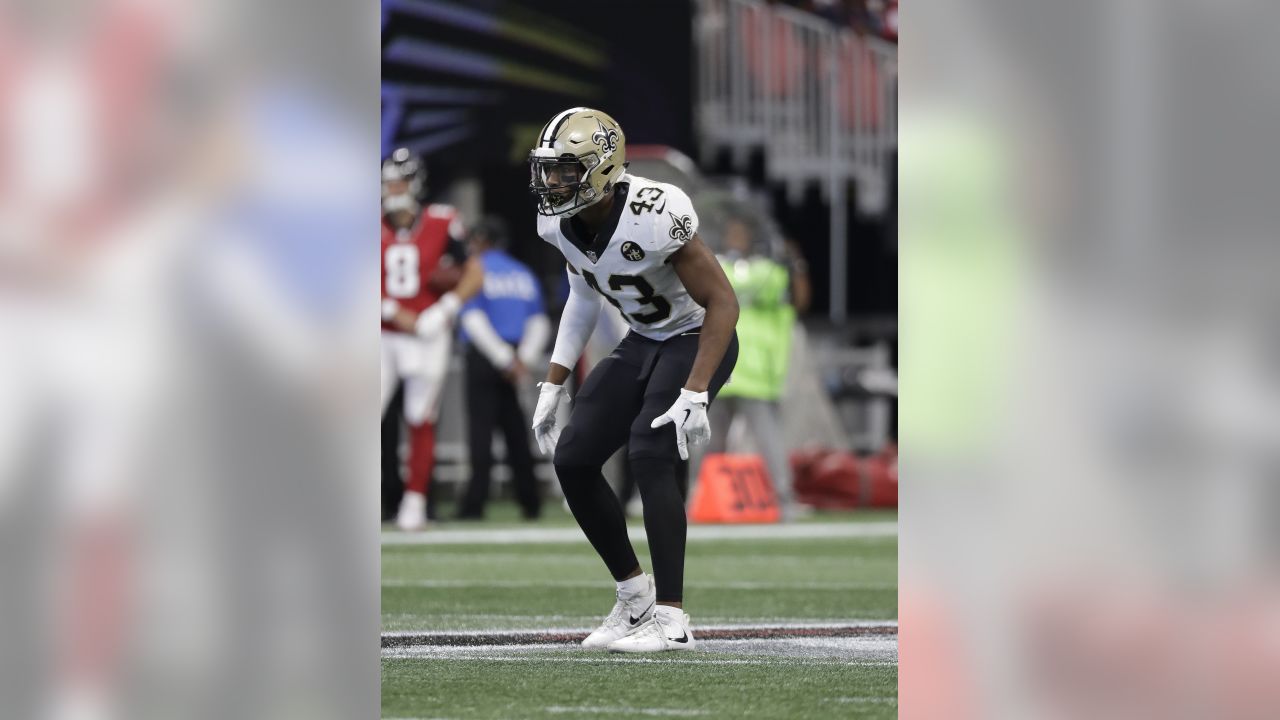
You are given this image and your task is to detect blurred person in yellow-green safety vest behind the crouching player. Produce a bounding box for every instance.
[708,218,809,521]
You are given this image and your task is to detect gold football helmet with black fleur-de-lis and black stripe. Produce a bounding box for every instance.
[529,108,627,218]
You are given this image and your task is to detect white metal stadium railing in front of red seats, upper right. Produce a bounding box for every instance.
[694,0,897,214]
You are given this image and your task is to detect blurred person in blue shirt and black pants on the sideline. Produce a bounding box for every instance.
[457,218,550,520]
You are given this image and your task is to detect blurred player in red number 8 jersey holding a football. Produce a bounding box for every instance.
[381,147,484,530]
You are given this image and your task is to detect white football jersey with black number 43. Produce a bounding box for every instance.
[538,174,707,340]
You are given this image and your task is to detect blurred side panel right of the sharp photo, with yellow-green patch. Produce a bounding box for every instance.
[899,0,1280,717]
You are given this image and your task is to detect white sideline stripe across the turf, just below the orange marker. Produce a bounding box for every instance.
[383,521,897,546]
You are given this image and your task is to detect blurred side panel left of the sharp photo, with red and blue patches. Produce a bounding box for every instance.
[0,0,379,719]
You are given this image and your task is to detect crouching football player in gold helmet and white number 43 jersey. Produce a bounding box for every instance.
[529,108,739,652]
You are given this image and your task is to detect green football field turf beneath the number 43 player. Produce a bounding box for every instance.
[381,506,897,719]
